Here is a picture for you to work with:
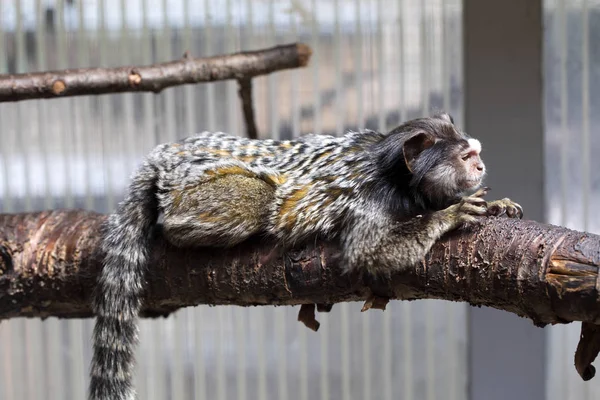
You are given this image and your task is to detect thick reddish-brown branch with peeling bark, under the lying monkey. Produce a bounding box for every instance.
[0,211,600,379]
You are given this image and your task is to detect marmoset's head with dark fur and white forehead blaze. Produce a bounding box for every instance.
[379,113,485,205]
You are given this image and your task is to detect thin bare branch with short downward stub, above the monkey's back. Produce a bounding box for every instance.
[0,43,312,138]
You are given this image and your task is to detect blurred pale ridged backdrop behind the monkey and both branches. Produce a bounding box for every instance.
[0,0,600,400]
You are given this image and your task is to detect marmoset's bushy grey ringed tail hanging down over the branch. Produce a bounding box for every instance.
[89,162,158,400]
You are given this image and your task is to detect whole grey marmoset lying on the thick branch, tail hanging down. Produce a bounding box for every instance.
[89,114,522,400]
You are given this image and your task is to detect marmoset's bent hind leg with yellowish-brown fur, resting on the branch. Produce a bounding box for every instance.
[163,173,275,247]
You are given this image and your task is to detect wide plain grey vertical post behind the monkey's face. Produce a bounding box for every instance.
[463,0,546,400]
